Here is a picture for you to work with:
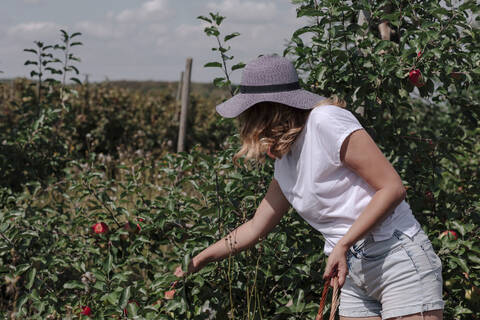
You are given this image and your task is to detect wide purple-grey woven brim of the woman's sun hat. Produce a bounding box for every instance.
[216,89,325,118]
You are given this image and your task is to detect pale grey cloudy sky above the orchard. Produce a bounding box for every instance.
[0,0,305,83]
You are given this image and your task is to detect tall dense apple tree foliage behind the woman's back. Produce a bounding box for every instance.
[285,0,480,319]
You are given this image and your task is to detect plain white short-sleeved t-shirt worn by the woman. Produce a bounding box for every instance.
[274,105,420,255]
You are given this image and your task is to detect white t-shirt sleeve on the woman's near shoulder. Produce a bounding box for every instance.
[314,106,363,166]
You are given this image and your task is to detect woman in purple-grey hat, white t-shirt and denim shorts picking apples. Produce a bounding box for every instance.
[175,56,444,320]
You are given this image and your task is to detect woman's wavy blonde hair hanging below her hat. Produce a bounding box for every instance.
[233,96,346,165]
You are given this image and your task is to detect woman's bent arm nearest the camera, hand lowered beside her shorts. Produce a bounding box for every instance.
[324,130,406,285]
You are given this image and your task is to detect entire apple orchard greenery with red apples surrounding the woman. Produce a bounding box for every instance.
[0,0,480,320]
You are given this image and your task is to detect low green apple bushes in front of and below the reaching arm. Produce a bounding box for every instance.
[0,146,323,319]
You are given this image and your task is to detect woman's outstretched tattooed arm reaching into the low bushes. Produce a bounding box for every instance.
[175,179,290,277]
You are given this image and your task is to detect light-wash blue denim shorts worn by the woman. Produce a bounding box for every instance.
[339,229,445,319]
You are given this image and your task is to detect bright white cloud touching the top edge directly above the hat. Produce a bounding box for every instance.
[207,0,281,23]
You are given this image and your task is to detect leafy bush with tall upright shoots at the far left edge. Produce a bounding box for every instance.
[0,30,81,194]
